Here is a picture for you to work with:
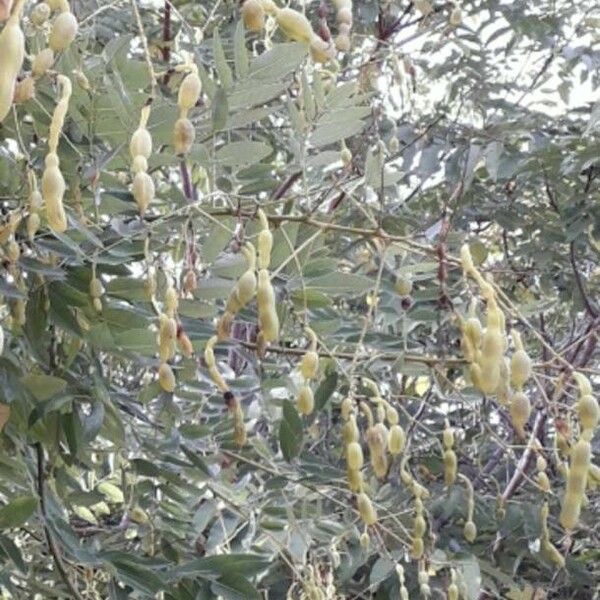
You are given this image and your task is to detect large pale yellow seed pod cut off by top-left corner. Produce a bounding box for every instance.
[0,1,25,123]
